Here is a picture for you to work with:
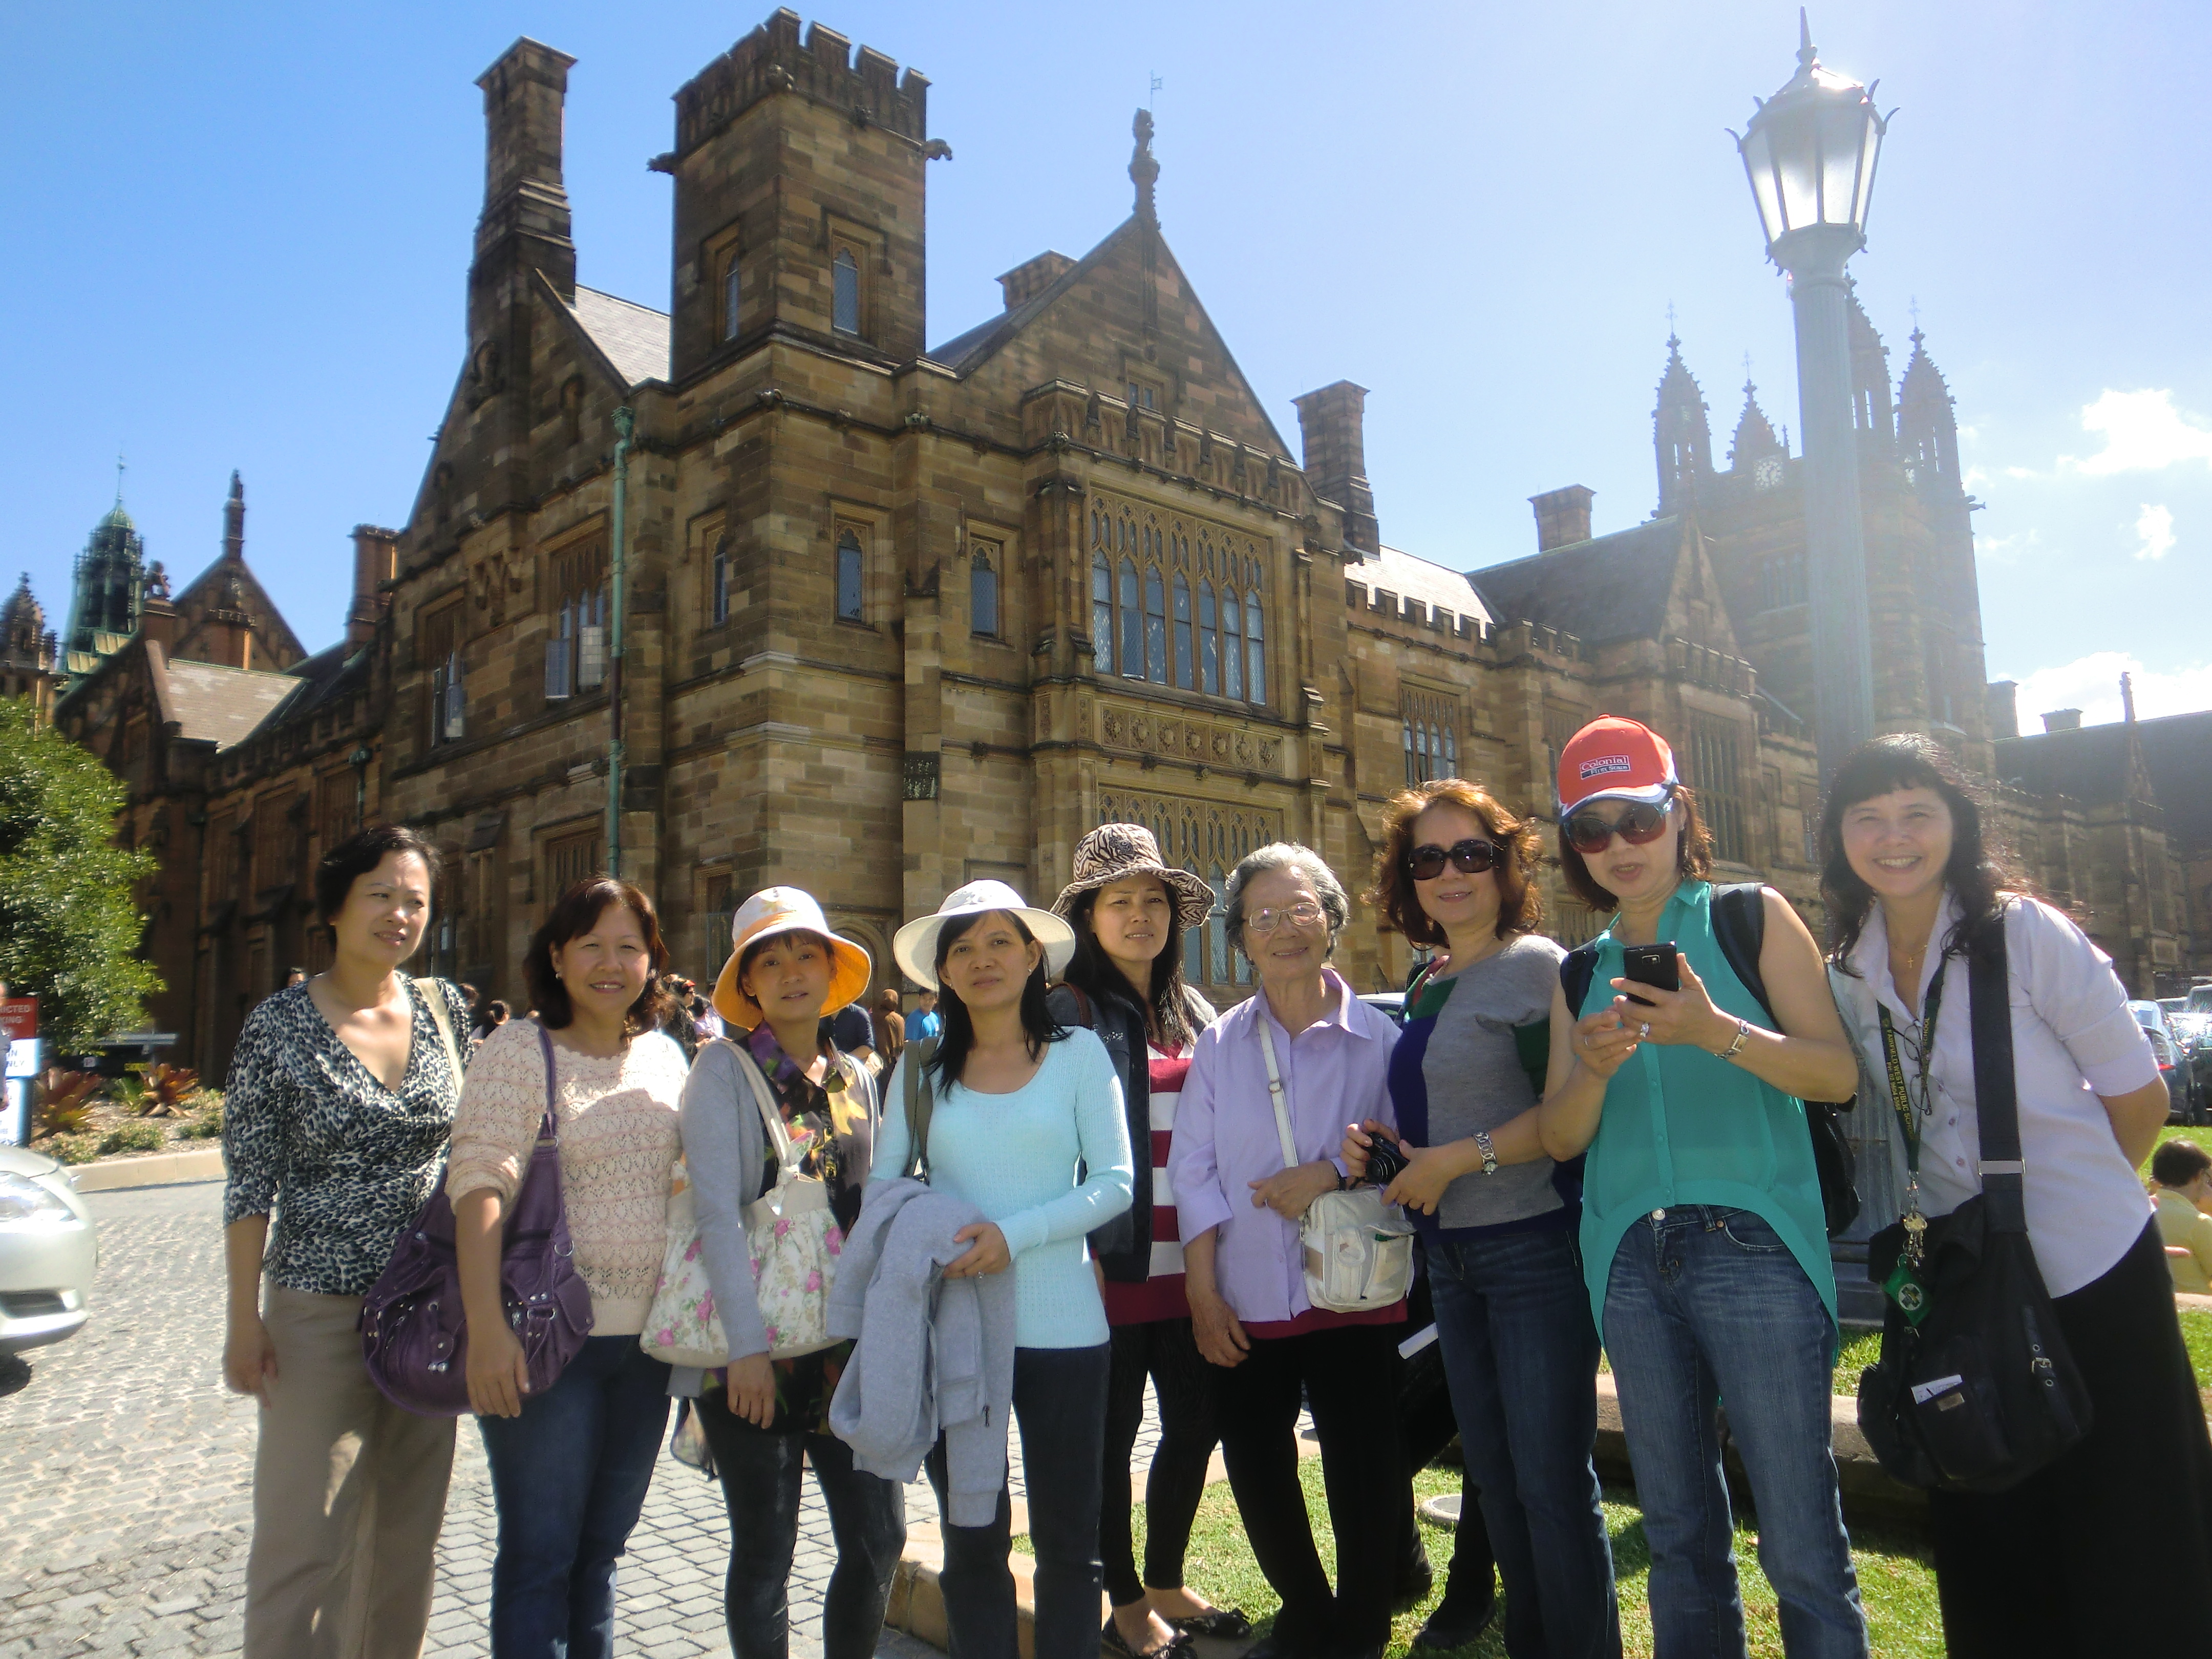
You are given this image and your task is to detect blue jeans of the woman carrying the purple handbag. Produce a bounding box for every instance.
[476,1336,668,1659]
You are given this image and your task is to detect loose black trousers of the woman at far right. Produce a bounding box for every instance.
[1929,1223,2212,1659]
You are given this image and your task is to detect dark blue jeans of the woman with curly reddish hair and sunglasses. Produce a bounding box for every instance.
[1422,1228,1622,1659]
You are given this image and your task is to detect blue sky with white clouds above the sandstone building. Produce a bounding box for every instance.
[0,0,2212,728]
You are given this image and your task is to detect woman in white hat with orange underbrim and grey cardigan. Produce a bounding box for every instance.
[684,887,907,1659]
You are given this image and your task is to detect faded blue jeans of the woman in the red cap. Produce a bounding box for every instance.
[1606,1203,1867,1659]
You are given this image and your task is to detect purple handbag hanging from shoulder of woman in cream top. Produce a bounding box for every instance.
[360,1026,590,1418]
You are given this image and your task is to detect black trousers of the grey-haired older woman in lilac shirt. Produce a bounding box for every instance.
[1217,1325,1407,1659]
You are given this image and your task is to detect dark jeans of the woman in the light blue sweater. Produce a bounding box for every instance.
[927,1343,1113,1659]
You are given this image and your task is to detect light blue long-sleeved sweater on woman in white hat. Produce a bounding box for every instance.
[869,1031,1133,1347]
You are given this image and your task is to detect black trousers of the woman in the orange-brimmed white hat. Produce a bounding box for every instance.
[697,1389,907,1659]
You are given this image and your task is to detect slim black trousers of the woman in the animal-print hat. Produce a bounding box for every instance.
[1099,1318,1219,1608]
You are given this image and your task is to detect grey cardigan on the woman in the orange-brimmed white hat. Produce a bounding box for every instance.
[670,1042,876,1394]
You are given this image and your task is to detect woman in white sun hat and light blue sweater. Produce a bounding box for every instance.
[876,880,1133,1659]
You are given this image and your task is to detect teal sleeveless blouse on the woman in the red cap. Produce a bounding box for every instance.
[1575,880,1836,1336]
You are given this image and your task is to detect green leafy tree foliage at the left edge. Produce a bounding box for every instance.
[0,697,161,1053]
